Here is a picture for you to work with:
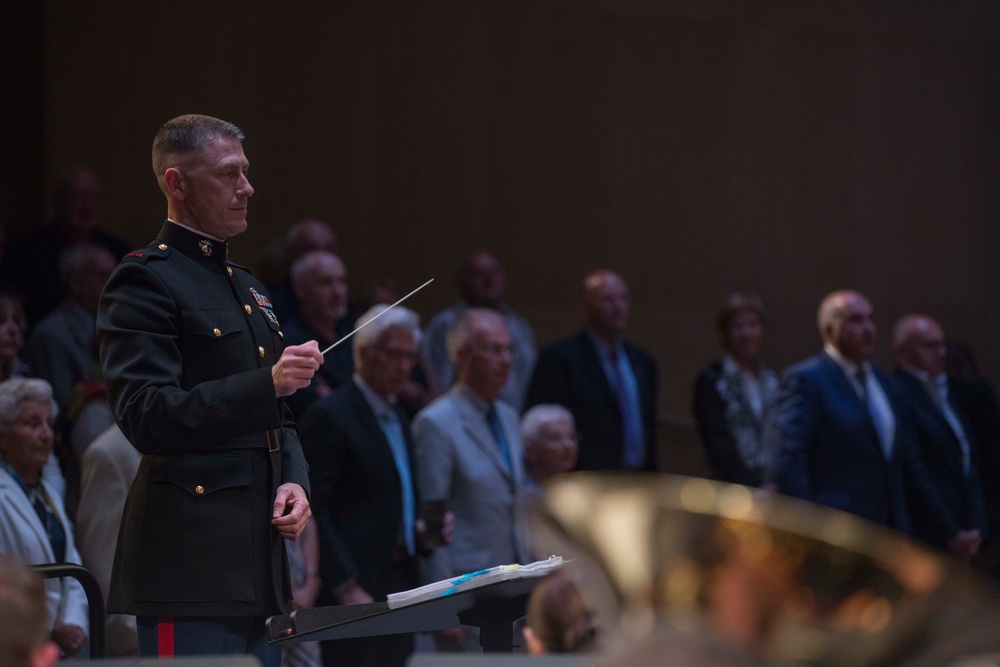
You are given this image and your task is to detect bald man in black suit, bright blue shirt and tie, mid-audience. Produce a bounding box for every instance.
[526,270,657,470]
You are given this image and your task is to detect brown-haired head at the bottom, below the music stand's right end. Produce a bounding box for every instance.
[524,572,597,655]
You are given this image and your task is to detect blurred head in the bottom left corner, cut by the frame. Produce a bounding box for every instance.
[0,554,59,667]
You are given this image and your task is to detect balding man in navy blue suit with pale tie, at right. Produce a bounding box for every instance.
[765,290,959,535]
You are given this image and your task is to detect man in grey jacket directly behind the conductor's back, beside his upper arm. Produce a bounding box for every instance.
[27,242,118,410]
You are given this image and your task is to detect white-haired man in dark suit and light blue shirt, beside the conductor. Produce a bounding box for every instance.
[292,305,442,666]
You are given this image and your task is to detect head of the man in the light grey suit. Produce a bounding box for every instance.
[454,308,514,402]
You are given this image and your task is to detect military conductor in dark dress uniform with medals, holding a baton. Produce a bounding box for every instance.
[98,115,323,665]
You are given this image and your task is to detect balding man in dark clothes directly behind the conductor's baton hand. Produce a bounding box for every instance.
[282,250,354,418]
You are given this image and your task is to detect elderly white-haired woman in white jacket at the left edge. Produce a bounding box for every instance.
[0,378,89,656]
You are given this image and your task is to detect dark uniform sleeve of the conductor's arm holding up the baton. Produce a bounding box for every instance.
[98,261,286,454]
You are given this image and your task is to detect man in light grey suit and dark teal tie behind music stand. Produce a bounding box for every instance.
[412,308,531,648]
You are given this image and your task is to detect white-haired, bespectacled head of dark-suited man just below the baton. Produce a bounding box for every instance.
[354,303,421,400]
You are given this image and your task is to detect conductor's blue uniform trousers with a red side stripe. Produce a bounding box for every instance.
[136,616,281,667]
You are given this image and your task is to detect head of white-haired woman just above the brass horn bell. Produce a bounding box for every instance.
[521,403,578,484]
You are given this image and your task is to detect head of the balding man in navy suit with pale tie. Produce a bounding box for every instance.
[816,290,878,364]
